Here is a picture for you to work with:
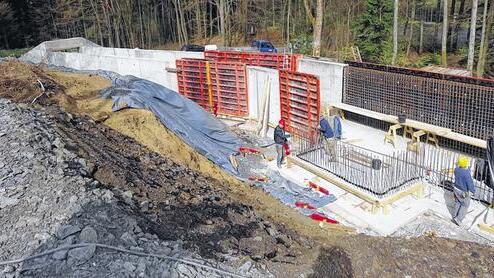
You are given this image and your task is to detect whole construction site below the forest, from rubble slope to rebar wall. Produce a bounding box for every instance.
[0,38,494,277]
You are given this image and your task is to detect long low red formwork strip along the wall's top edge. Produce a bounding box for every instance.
[204,50,299,71]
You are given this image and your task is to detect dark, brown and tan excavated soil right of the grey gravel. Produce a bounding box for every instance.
[0,59,494,277]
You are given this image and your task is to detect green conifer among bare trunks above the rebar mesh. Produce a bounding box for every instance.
[353,0,393,63]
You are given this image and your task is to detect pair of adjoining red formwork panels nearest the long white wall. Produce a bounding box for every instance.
[176,59,249,117]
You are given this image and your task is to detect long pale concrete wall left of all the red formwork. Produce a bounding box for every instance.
[21,38,204,91]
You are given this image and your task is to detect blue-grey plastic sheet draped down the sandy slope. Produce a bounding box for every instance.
[102,76,242,174]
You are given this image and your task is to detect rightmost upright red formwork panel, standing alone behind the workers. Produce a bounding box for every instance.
[279,70,321,136]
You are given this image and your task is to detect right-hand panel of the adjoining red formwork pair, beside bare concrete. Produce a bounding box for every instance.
[210,62,249,117]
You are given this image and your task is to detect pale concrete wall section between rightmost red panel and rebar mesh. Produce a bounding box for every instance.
[298,58,347,106]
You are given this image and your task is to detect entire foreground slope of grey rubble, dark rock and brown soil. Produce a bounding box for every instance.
[0,63,494,277]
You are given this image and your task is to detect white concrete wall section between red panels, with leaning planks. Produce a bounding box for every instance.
[247,66,281,125]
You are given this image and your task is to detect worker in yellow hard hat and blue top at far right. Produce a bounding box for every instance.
[453,156,475,226]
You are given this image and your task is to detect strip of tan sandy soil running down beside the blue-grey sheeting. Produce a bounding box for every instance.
[0,60,235,182]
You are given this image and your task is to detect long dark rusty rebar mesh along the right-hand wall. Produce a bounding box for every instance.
[343,63,494,140]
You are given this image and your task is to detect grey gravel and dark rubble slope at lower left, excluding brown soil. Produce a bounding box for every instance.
[0,99,314,277]
